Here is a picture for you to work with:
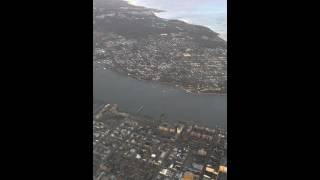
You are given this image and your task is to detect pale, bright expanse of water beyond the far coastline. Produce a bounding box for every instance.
[128,0,227,40]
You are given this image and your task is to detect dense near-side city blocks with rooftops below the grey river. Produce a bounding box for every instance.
[93,104,227,180]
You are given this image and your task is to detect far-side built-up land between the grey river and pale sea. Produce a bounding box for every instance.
[93,0,227,94]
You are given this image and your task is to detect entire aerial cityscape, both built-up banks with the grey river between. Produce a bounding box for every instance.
[93,0,227,180]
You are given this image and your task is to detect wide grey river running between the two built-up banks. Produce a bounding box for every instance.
[93,65,227,128]
